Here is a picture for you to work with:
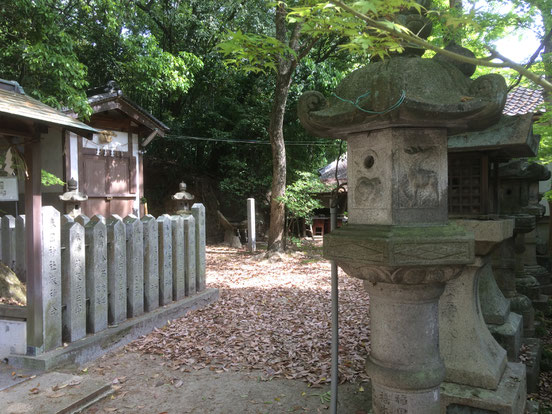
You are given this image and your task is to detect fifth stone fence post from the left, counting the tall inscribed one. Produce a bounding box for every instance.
[124,214,144,318]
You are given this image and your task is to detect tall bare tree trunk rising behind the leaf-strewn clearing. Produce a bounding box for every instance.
[268,67,293,251]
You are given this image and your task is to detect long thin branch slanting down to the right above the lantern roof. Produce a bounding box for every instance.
[331,0,552,92]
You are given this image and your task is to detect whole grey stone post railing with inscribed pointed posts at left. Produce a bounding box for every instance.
[0,204,205,351]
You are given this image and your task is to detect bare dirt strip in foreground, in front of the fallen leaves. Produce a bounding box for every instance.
[74,351,371,414]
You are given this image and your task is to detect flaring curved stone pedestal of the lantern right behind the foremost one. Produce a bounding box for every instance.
[439,220,527,413]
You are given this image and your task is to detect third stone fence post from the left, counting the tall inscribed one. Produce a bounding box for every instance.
[84,215,107,333]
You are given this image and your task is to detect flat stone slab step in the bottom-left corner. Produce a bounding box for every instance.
[0,372,113,414]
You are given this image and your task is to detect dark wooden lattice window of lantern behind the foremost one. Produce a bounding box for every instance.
[448,153,489,215]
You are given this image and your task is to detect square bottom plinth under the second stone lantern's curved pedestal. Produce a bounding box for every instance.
[441,362,527,414]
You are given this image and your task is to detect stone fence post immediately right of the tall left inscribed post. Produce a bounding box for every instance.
[61,219,86,342]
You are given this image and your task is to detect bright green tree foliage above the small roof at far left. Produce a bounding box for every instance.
[0,0,91,116]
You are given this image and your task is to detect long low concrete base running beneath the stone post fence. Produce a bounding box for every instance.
[7,289,219,370]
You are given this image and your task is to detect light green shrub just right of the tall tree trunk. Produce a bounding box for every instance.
[279,171,328,219]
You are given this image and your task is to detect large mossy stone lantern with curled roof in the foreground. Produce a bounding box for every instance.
[299,9,506,414]
